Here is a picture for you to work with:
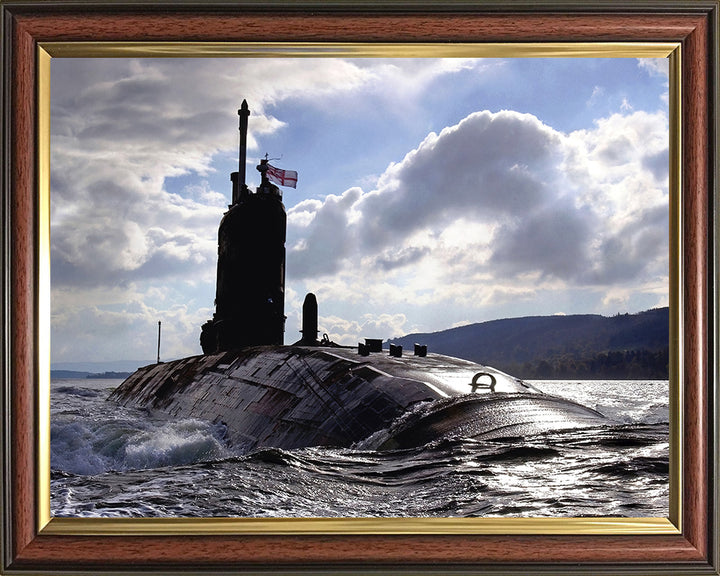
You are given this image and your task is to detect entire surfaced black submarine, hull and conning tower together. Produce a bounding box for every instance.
[109,100,606,453]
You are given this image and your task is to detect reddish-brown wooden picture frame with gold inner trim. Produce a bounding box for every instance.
[1,0,719,574]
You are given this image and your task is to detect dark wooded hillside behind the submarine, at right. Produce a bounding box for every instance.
[389,308,669,379]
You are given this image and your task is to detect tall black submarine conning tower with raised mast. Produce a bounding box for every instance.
[200,100,287,354]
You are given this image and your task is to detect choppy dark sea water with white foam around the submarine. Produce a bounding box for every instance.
[50,379,669,517]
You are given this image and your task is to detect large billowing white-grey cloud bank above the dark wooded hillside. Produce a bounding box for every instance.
[288,111,668,305]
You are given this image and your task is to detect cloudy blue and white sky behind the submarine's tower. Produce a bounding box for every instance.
[50,58,669,367]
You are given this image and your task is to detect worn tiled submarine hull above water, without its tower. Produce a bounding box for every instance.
[110,346,603,452]
